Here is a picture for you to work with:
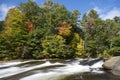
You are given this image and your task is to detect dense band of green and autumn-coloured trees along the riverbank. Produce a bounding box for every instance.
[0,0,120,60]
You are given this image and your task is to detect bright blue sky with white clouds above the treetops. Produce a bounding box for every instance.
[0,0,120,20]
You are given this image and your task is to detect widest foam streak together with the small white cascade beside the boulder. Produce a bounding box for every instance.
[20,60,103,80]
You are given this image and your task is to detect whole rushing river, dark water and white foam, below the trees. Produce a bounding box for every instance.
[0,59,120,80]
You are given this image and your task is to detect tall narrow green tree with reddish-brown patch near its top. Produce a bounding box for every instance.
[81,9,99,56]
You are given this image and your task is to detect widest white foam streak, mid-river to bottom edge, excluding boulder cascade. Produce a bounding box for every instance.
[20,65,90,80]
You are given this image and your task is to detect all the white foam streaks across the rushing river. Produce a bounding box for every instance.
[0,59,103,80]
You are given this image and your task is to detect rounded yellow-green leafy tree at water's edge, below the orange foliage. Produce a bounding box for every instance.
[41,35,73,58]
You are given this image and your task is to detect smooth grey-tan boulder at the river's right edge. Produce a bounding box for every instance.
[103,56,120,76]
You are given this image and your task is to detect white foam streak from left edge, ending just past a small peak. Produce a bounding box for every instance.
[0,61,63,78]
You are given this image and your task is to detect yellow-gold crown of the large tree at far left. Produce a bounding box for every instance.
[5,8,28,35]
